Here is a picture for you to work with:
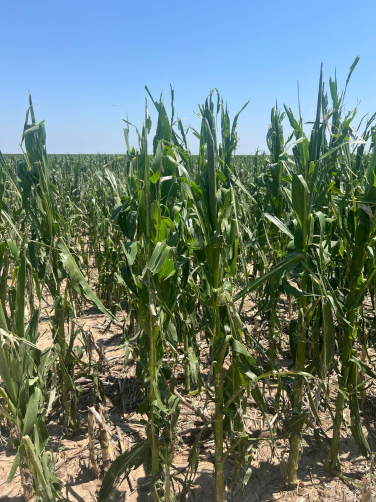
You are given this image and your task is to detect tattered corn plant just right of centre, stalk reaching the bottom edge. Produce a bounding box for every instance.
[191,94,248,502]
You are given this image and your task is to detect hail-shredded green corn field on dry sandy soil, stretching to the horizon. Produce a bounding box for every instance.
[0,58,376,502]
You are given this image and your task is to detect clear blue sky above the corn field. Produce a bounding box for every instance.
[0,0,376,154]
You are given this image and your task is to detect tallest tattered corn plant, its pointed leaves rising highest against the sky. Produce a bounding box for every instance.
[262,57,366,489]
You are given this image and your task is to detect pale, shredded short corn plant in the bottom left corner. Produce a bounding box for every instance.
[0,251,61,502]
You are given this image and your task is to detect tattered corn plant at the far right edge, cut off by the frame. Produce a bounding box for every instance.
[325,123,376,474]
